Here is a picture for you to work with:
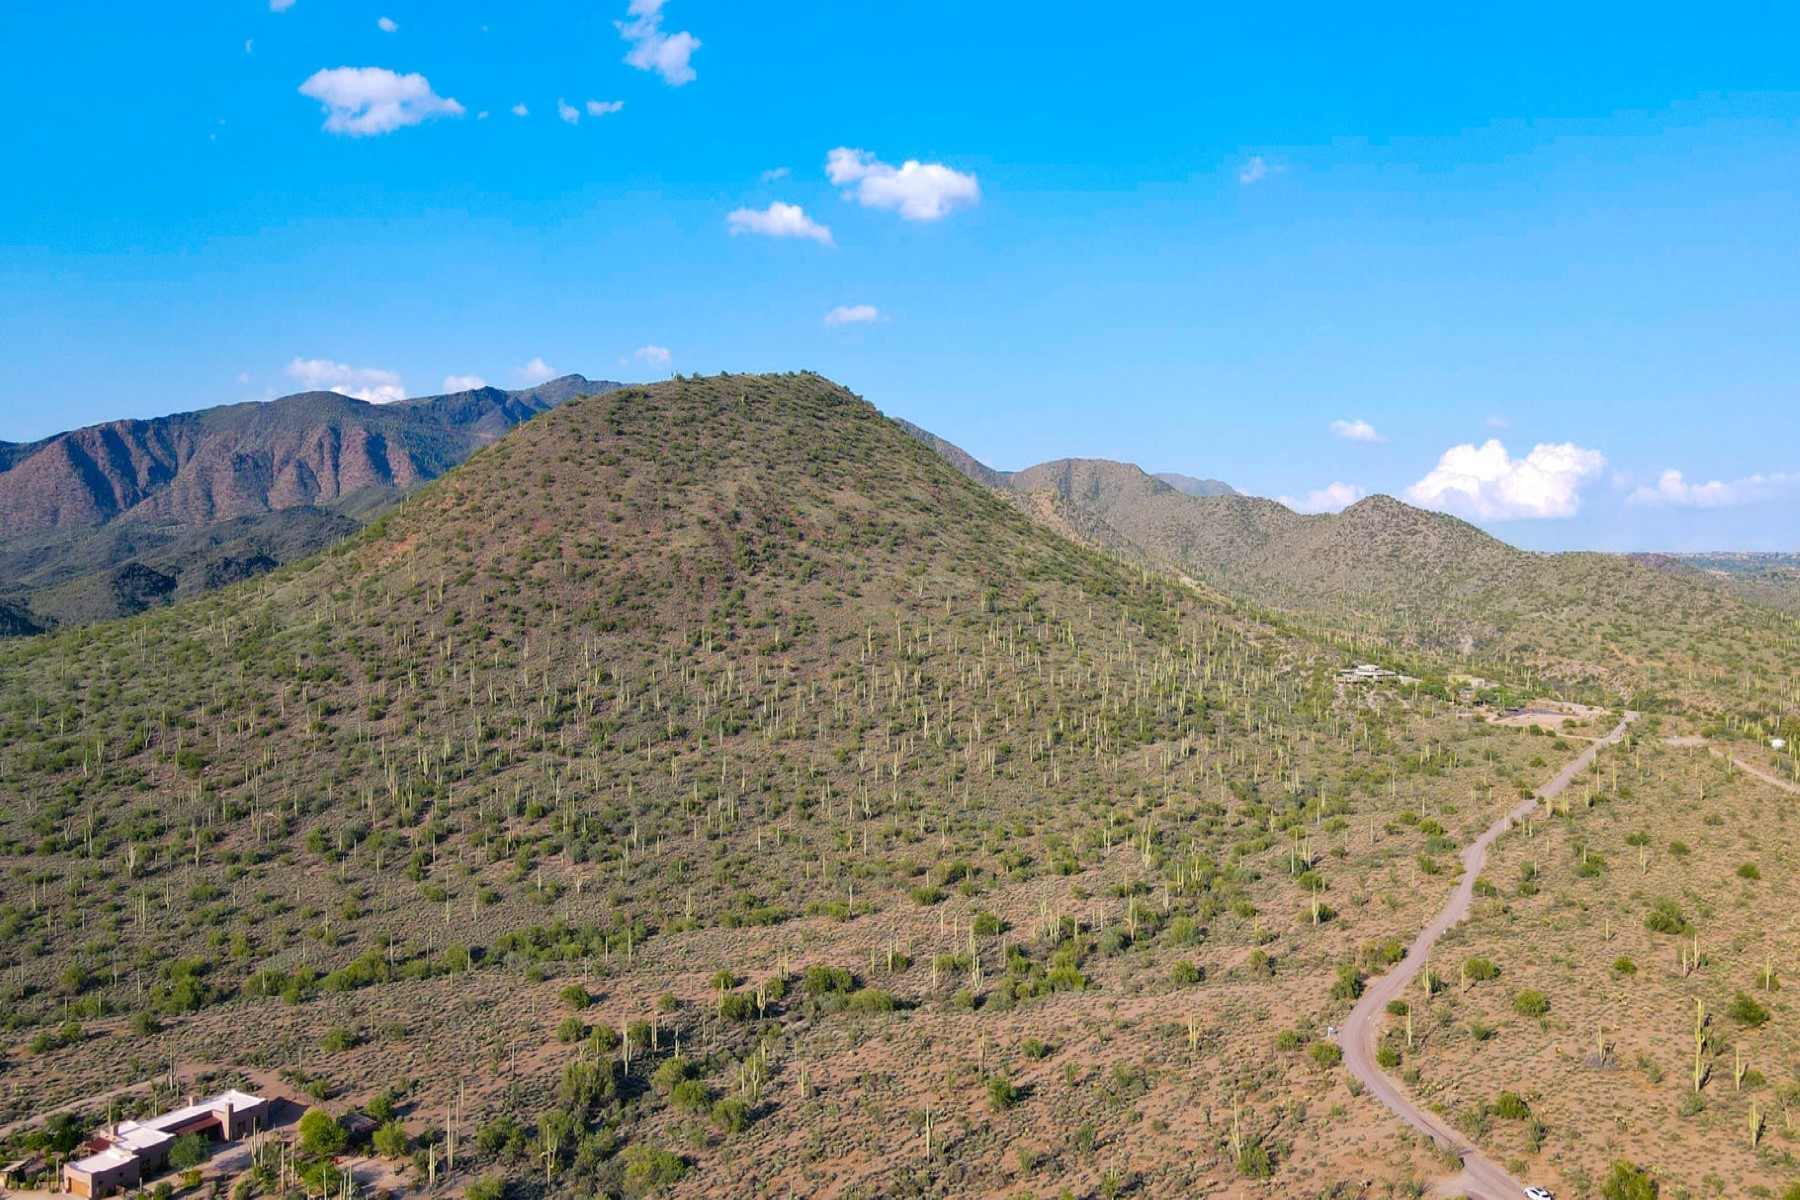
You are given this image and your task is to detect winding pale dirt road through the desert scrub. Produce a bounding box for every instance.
[1337,712,1638,1200]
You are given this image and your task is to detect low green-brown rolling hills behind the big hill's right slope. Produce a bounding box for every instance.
[927,424,1795,705]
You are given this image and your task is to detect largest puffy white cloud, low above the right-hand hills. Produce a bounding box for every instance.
[1406,439,1606,520]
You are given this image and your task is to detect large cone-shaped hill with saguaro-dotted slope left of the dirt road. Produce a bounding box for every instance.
[0,376,1562,1196]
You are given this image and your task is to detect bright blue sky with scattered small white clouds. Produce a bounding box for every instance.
[0,0,1800,551]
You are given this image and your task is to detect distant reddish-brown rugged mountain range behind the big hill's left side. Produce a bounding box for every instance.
[0,376,617,635]
